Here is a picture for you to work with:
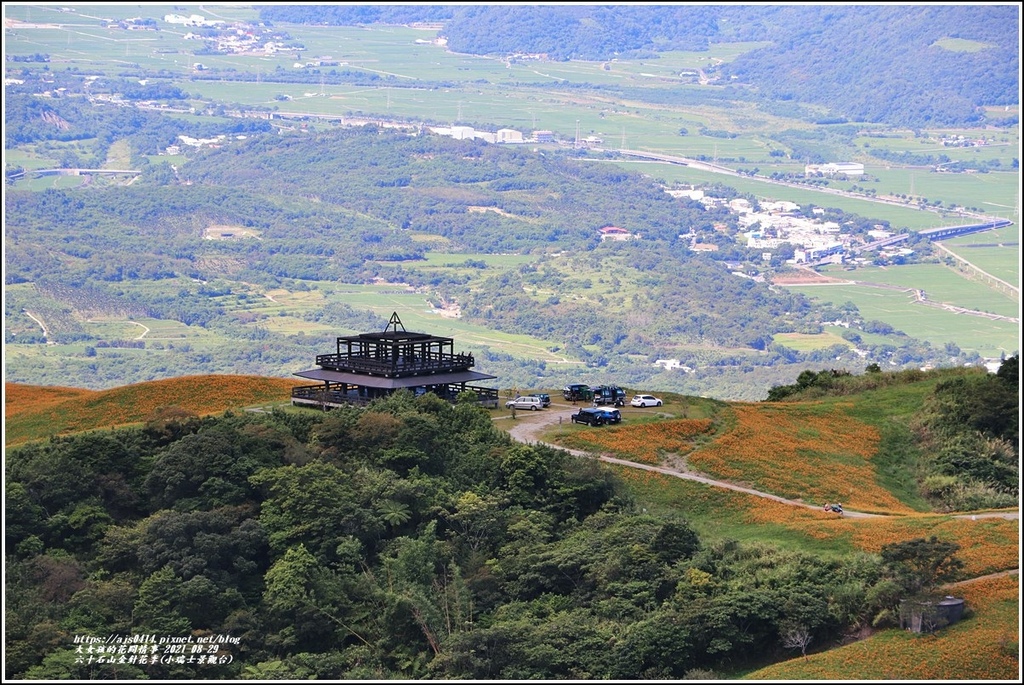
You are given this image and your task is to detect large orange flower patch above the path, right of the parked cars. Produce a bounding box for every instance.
[689,403,911,513]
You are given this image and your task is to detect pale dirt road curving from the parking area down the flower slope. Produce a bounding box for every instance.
[501,402,1020,519]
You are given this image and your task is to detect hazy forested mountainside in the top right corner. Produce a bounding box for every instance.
[722,4,1020,127]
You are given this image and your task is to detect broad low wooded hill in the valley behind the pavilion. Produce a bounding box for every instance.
[5,121,983,398]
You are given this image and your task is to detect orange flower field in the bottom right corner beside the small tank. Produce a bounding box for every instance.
[744,575,1020,682]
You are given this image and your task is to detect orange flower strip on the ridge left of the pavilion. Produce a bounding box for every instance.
[4,375,295,444]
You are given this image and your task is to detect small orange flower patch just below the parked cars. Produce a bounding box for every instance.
[561,419,712,464]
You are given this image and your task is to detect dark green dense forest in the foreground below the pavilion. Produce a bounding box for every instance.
[4,374,987,680]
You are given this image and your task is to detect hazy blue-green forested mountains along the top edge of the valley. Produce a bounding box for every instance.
[260,4,1020,127]
